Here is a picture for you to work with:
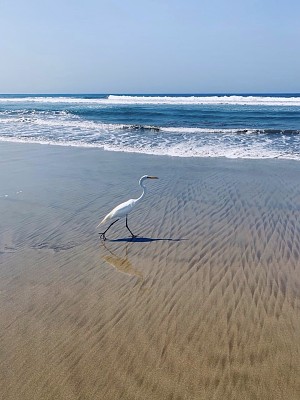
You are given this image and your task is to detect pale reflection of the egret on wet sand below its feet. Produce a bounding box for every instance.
[100,242,143,281]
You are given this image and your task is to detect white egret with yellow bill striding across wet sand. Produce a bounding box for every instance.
[97,175,158,240]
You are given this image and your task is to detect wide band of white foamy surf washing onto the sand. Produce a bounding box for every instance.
[0,111,300,160]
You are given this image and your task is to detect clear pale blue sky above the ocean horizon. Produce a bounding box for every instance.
[0,0,300,93]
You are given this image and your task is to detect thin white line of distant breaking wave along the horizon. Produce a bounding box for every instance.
[0,95,300,107]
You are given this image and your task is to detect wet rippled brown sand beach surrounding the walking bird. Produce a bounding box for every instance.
[0,144,300,400]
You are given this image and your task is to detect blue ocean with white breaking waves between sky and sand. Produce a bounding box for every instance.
[0,94,300,160]
